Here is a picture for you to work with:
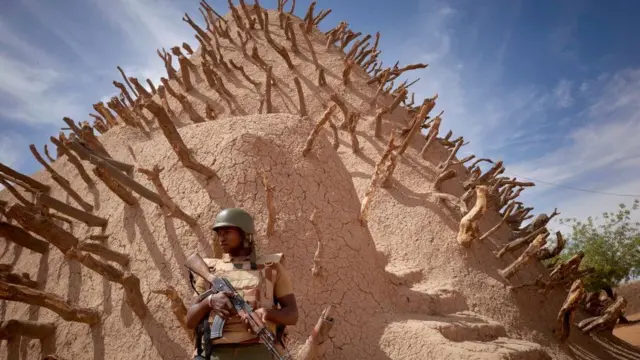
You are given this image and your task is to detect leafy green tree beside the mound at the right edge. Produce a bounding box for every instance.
[559,199,640,291]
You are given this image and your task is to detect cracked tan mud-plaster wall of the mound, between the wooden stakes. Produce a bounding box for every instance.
[0,6,632,359]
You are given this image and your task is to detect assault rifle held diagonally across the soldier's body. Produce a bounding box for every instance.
[185,254,291,360]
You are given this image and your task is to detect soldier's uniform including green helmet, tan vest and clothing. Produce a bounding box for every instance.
[195,209,293,360]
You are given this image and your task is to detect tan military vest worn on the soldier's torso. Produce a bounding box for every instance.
[204,253,283,344]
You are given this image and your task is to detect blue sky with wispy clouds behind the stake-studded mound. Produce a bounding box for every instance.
[0,0,640,228]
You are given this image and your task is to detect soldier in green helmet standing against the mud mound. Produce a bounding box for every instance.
[186,208,298,360]
